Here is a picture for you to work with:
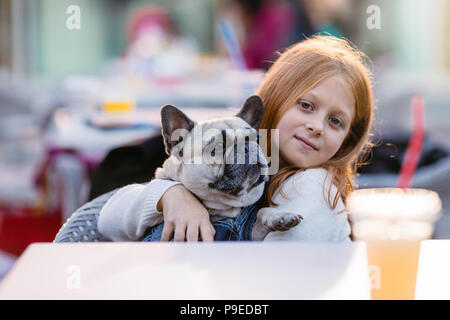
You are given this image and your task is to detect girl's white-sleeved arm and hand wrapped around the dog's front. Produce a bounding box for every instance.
[98,179,215,241]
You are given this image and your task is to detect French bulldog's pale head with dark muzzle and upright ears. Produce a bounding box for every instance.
[156,96,268,209]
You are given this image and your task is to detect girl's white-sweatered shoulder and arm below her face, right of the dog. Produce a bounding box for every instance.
[265,168,351,242]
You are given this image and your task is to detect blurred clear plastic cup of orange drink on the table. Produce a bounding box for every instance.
[347,188,441,300]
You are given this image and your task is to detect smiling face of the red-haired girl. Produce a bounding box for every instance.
[277,77,355,168]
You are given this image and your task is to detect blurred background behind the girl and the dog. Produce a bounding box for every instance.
[0,0,450,278]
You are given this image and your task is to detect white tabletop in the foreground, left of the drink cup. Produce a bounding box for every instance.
[0,242,370,300]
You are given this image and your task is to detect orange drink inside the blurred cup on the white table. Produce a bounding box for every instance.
[366,240,420,300]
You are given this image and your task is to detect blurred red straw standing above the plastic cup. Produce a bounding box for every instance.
[397,95,425,188]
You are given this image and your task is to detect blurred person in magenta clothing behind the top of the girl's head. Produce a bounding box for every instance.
[219,0,350,70]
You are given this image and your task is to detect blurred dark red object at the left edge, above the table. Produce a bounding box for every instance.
[0,204,61,256]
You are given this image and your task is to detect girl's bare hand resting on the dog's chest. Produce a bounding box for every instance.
[157,184,216,242]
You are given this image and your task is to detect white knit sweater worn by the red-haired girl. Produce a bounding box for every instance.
[98,168,351,242]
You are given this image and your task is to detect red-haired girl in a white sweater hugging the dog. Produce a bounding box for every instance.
[98,36,373,241]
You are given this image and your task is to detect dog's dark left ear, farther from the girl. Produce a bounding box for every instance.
[161,105,194,156]
